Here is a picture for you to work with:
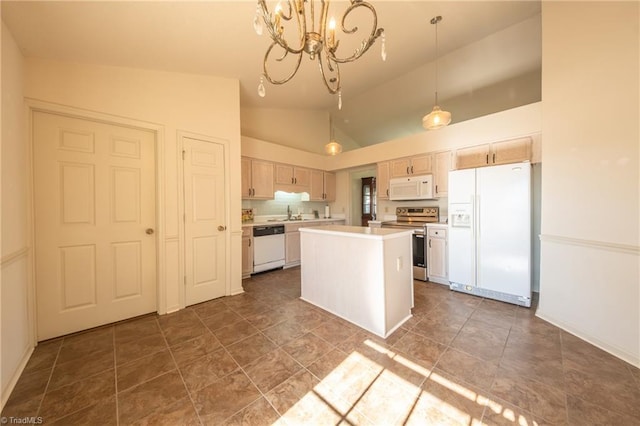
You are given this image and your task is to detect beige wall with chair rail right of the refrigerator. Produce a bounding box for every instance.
[538,2,640,366]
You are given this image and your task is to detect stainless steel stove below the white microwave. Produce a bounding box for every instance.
[382,207,440,281]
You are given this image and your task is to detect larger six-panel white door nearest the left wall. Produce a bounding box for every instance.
[33,112,157,340]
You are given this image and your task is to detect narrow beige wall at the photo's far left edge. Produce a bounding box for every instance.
[0,23,34,406]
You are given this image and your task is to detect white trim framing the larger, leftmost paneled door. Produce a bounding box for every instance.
[25,98,167,320]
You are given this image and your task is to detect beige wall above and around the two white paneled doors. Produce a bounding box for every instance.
[25,58,242,313]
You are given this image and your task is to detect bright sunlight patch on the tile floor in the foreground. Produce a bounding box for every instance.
[276,339,537,426]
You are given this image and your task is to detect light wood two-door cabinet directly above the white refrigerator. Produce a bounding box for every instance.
[456,137,531,169]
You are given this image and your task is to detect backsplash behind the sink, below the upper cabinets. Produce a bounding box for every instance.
[242,191,327,217]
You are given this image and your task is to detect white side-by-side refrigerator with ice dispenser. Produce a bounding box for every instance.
[448,163,531,307]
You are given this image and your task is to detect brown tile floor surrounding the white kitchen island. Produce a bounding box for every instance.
[2,268,640,425]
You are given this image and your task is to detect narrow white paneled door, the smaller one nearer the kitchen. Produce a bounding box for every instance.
[182,137,226,305]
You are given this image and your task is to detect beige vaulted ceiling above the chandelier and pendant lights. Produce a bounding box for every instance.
[2,0,541,153]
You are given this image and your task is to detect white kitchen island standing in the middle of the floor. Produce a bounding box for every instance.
[300,225,413,338]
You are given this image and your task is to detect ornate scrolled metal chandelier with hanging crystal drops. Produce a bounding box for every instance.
[253,0,387,109]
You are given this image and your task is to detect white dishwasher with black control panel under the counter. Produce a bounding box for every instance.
[253,225,284,272]
